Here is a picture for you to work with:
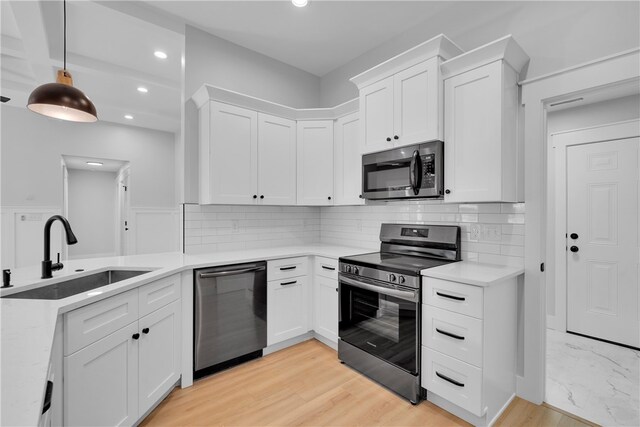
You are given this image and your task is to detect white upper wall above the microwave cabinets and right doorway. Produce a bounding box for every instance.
[321,1,640,106]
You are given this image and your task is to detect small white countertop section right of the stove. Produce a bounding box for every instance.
[422,261,524,287]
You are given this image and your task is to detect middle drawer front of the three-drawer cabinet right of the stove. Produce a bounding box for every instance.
[422,304,482,368]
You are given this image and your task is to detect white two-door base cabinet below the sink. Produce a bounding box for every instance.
[63,275,181,426]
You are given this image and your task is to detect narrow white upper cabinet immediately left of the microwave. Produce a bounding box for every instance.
[333,113,364,205]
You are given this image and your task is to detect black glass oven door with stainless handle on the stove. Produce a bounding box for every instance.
[339,274,420,375]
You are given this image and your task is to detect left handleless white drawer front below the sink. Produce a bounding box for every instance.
[64,289,138,356]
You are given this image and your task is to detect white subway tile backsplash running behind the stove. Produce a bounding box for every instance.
[185,201,525,265]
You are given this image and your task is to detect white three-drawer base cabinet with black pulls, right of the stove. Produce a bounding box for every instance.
[421,277,517,425]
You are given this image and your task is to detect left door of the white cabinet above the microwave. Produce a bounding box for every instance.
[360,76,393,153]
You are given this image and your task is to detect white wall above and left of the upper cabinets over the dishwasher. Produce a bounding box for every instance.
[184,25,320,203]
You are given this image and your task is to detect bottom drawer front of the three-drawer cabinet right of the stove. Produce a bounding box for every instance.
[422,346,484,417]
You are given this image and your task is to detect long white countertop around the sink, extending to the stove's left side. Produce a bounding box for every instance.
[0,245,371,426]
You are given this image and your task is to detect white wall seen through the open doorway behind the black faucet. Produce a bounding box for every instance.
[67,169,117,258]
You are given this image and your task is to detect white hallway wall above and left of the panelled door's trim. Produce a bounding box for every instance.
[546,95,640,320]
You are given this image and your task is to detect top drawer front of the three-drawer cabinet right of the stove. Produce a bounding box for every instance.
[423,277,484,319]
